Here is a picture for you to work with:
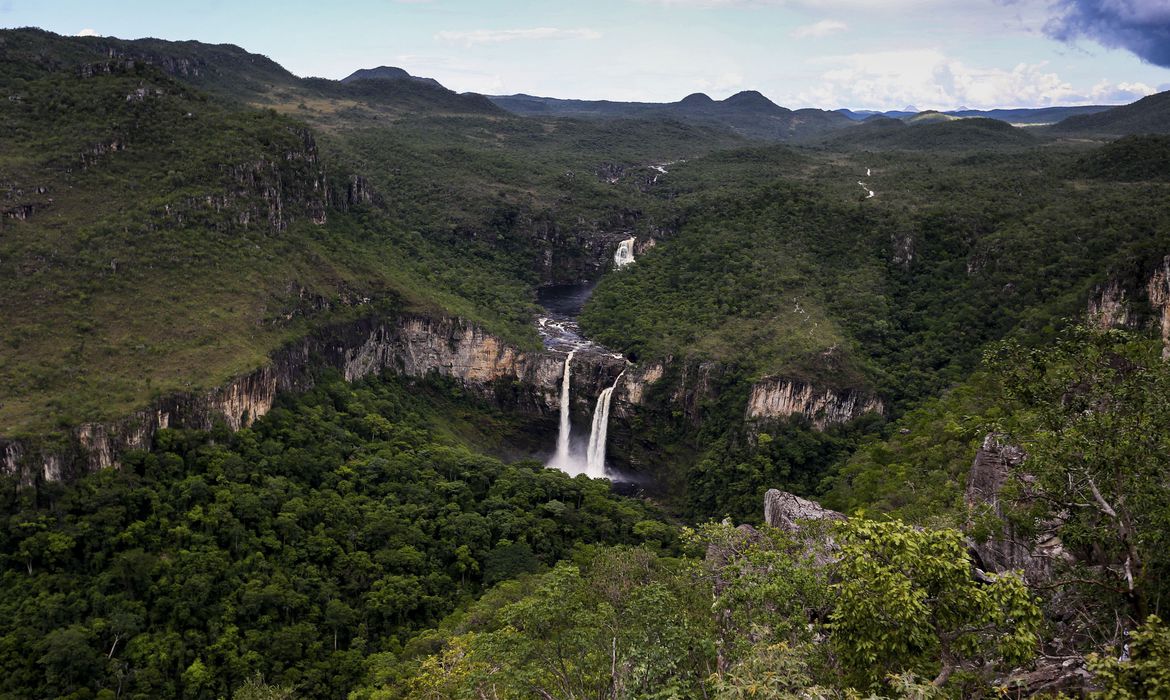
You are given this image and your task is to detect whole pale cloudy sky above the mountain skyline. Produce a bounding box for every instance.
[0,0,1170,110]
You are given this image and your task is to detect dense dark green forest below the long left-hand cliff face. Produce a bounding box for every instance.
[0,378,662,698]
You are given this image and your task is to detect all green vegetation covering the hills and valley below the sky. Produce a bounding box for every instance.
[0,29,1170,700]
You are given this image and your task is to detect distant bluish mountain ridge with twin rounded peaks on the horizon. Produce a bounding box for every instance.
[490,90,854,142]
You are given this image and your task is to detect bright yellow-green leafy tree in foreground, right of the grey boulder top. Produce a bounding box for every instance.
[830,521,1040,686]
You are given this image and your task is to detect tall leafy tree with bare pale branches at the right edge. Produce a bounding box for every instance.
[987,328,1170,624]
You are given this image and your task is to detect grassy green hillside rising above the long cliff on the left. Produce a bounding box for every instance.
[0,30,744,438]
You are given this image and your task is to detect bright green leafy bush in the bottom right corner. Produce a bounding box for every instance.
[1089,615,1170,700]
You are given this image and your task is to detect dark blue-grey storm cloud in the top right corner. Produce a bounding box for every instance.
[1044,0,1170,68]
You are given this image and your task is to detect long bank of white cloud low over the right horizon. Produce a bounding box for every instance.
[793,49,1155,109]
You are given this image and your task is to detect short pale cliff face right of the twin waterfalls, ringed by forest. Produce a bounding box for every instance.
[748,378,885,430]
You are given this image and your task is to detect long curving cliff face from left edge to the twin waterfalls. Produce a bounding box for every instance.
[0,316,625,483]
